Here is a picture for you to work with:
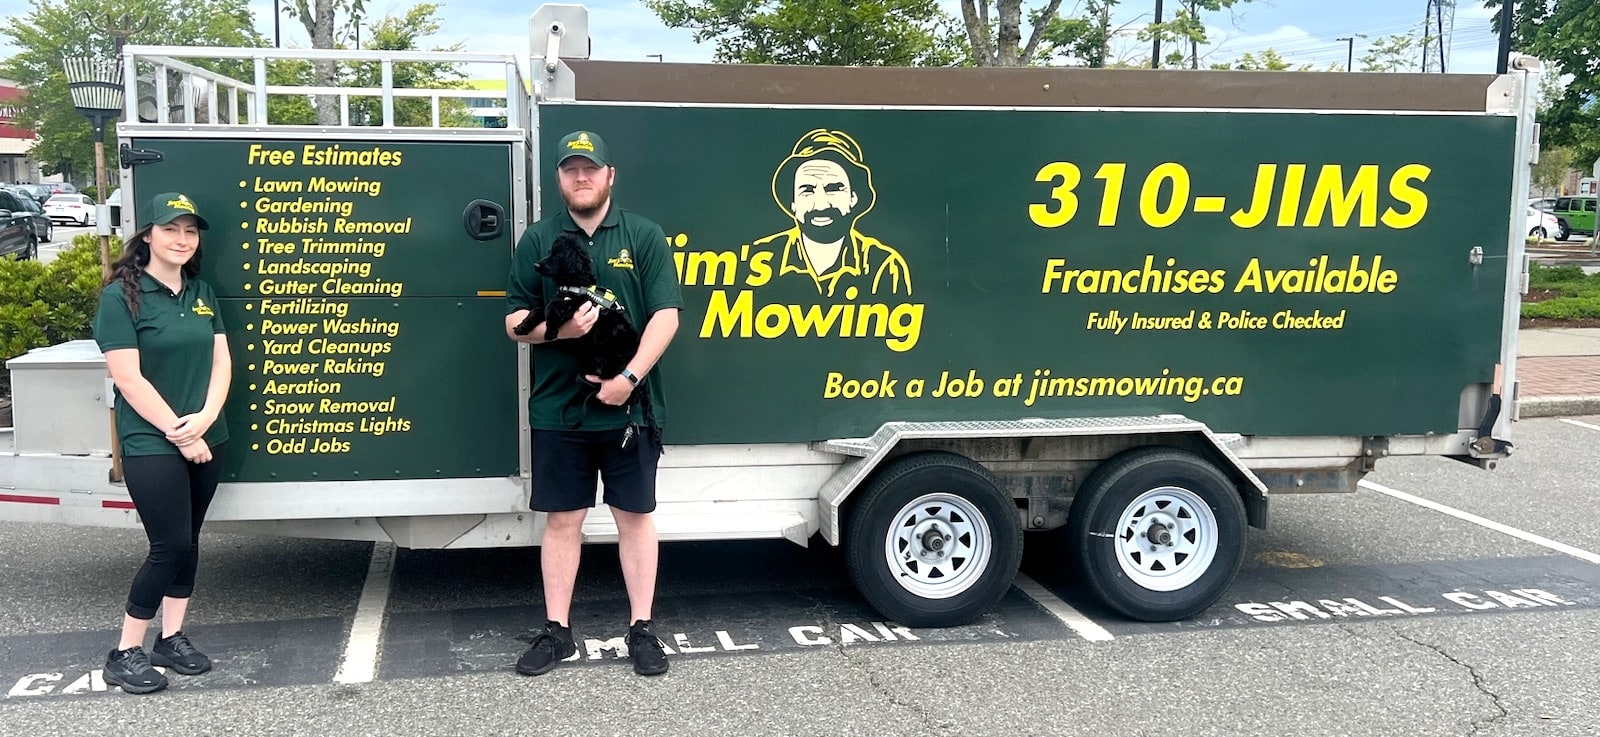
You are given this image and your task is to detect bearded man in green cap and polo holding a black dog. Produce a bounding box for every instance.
[506,131,683,675]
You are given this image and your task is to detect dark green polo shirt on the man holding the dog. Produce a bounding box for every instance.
[506,203,683,430]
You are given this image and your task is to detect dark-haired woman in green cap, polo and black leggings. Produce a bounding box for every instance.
[94,192,232,694]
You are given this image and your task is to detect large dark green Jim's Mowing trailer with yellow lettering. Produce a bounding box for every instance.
[0,5,1538,625]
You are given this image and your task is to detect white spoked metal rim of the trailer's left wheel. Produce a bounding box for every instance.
[883,492,994,600]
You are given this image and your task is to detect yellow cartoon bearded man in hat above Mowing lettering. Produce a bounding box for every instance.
[754,128,910,297]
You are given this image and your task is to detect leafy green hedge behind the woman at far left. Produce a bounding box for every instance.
[0,235,122,396]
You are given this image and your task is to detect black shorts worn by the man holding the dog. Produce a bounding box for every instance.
[528,430,661,515]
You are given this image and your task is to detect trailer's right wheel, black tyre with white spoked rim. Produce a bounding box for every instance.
[1067,448,1246,622]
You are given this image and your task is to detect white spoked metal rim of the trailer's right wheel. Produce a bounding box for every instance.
[1115,486,1218,592]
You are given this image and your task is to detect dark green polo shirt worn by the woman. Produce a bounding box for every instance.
[94,273,227,456]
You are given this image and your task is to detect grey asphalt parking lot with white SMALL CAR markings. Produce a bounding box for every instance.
[0,417,1600,735]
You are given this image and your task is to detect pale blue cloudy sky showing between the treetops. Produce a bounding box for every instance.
[0,0,1496,74]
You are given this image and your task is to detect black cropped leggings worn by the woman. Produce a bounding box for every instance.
[122,448,222,619]
